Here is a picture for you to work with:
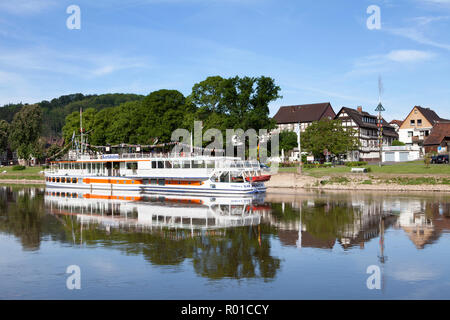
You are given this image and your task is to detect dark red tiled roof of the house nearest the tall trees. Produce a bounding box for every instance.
[273,102,334,124]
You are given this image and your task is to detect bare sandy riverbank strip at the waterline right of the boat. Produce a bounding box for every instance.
[266,172,450,192]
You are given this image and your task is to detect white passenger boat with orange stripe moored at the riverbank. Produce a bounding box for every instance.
[45,153,270,195]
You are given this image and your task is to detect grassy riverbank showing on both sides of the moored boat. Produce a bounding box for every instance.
[0,161,450,192]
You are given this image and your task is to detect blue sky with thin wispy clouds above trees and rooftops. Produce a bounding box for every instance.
[0,0,450,120]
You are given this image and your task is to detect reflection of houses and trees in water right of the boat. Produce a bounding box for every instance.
[263,193,450,251]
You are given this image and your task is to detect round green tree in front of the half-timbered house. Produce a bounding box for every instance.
[300,120,359,157]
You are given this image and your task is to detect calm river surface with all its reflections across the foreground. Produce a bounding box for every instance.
[0,187,450,299]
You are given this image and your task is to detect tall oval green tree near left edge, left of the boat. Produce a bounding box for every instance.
[9,105,42,161]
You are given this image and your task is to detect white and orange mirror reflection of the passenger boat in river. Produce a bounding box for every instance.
[45,188,270,239]
